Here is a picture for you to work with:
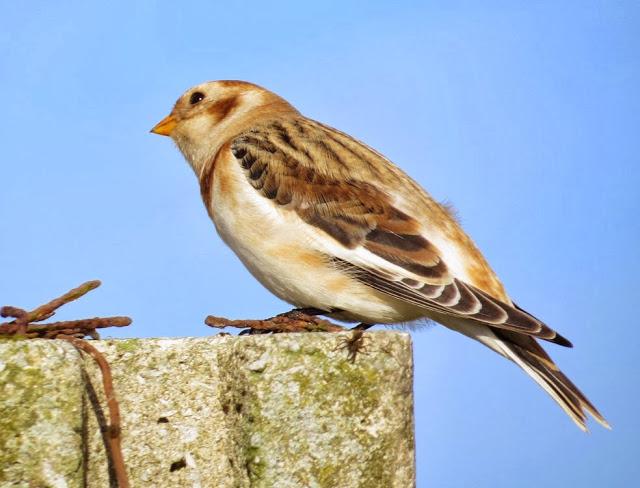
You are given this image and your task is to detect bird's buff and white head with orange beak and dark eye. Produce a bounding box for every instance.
[151,80,297,173]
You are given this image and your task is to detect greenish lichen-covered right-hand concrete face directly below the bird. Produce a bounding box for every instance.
[224,332,415,488]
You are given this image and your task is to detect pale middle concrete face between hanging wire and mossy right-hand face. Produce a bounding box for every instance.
[82,338,248,488]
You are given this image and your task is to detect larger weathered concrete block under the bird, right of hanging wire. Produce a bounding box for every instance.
[0,332,415,488]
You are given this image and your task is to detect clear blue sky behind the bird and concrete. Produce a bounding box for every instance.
[0,1,640,488]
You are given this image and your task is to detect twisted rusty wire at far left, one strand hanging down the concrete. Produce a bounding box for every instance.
[0,280,131,488]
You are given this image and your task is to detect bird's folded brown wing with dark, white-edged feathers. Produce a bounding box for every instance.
[231,119,571,346]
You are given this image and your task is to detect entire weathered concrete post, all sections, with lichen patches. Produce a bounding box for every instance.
[0,331,415,488]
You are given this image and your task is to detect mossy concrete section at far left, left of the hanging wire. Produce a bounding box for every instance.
[0,339,84,488]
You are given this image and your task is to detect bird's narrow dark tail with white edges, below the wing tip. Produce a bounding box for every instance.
[452,326,611,432]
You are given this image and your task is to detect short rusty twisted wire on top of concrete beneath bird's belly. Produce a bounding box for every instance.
[204,308,344,335]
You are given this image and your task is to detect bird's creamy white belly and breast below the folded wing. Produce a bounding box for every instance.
[205,159,418,323]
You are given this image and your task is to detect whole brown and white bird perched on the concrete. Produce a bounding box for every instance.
[151,80,610,431]
